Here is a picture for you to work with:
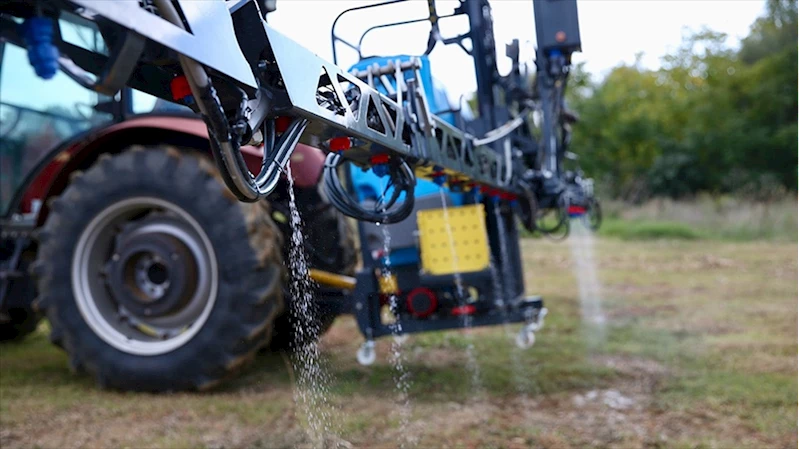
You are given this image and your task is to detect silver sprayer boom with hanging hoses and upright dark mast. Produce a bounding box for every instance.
[0,0,592,227]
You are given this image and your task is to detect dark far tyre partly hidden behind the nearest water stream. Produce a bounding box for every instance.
[269,179,358,351]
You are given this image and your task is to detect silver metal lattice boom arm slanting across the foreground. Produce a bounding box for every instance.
[1,0,516,206]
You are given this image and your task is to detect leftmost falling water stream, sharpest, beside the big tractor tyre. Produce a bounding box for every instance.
[286,164,336,447]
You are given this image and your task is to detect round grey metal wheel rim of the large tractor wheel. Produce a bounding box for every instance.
[72,197,219,355]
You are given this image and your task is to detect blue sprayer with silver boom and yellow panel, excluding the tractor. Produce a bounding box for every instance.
[0,0,601,368]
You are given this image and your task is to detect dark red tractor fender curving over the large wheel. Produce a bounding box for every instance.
[9,114,325,227]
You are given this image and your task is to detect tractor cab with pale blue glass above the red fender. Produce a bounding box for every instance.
[0,12,197,217]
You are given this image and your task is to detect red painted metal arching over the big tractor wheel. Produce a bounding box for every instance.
[19,115,325,223]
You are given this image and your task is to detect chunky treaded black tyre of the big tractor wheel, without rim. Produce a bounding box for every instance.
[37,145,285,391]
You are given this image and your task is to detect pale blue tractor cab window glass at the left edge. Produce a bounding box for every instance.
[0,15,113,215]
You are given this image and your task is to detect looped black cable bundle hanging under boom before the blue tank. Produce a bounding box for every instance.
[324,153,416,224]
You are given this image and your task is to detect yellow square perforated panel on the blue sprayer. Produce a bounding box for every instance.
[416,204,489,275]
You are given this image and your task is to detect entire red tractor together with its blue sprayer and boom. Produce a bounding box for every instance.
[0,0,600,390]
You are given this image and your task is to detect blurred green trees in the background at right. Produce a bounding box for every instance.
[567,0,797,201]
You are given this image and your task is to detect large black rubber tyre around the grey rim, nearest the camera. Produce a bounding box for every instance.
[34,147,285,392]
